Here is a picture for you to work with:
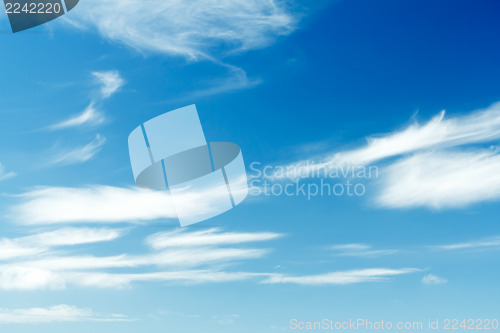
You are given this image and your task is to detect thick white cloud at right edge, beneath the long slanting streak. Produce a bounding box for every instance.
[376,151,500,209]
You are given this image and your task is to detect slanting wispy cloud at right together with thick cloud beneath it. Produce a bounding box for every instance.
[273,103,500,209]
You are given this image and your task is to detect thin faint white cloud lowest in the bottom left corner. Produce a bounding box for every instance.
[0,304,131,324]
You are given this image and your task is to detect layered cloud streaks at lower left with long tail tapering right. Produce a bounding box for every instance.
[0,228,420,290]
